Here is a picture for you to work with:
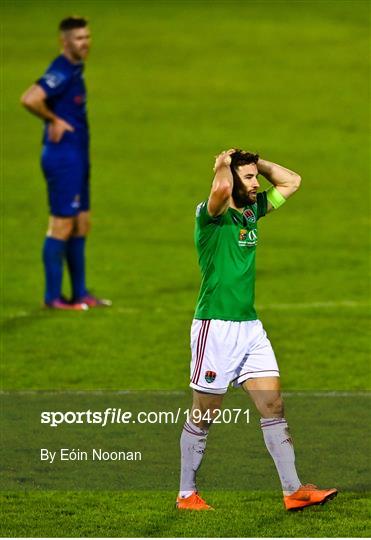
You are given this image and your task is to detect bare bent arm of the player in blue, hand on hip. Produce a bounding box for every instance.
[21,84,74,143]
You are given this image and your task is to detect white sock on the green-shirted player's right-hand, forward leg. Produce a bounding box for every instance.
[260,418,301,495]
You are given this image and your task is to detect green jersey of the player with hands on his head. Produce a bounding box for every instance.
[195,191,267,321]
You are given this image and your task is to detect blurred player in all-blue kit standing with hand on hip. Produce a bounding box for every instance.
[21,17,111,310]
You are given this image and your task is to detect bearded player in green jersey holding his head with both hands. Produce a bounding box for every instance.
[177,149,337,510]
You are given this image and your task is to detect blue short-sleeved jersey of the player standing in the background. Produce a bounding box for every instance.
[36,54,89,151]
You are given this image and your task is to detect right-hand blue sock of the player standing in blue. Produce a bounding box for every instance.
[66,236,87,300]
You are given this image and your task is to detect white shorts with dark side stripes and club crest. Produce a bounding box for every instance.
[189,319,279,394]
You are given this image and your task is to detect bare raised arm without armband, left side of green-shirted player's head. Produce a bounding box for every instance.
[207,149,234,216]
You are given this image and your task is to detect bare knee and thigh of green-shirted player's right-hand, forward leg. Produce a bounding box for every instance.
[242,377,284,418]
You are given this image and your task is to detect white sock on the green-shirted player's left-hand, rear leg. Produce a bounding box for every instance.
[179,421,208,498]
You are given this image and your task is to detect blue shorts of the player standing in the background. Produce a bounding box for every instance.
[41,144,90,217]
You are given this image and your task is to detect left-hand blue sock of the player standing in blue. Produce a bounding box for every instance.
[43,236,66,303]
